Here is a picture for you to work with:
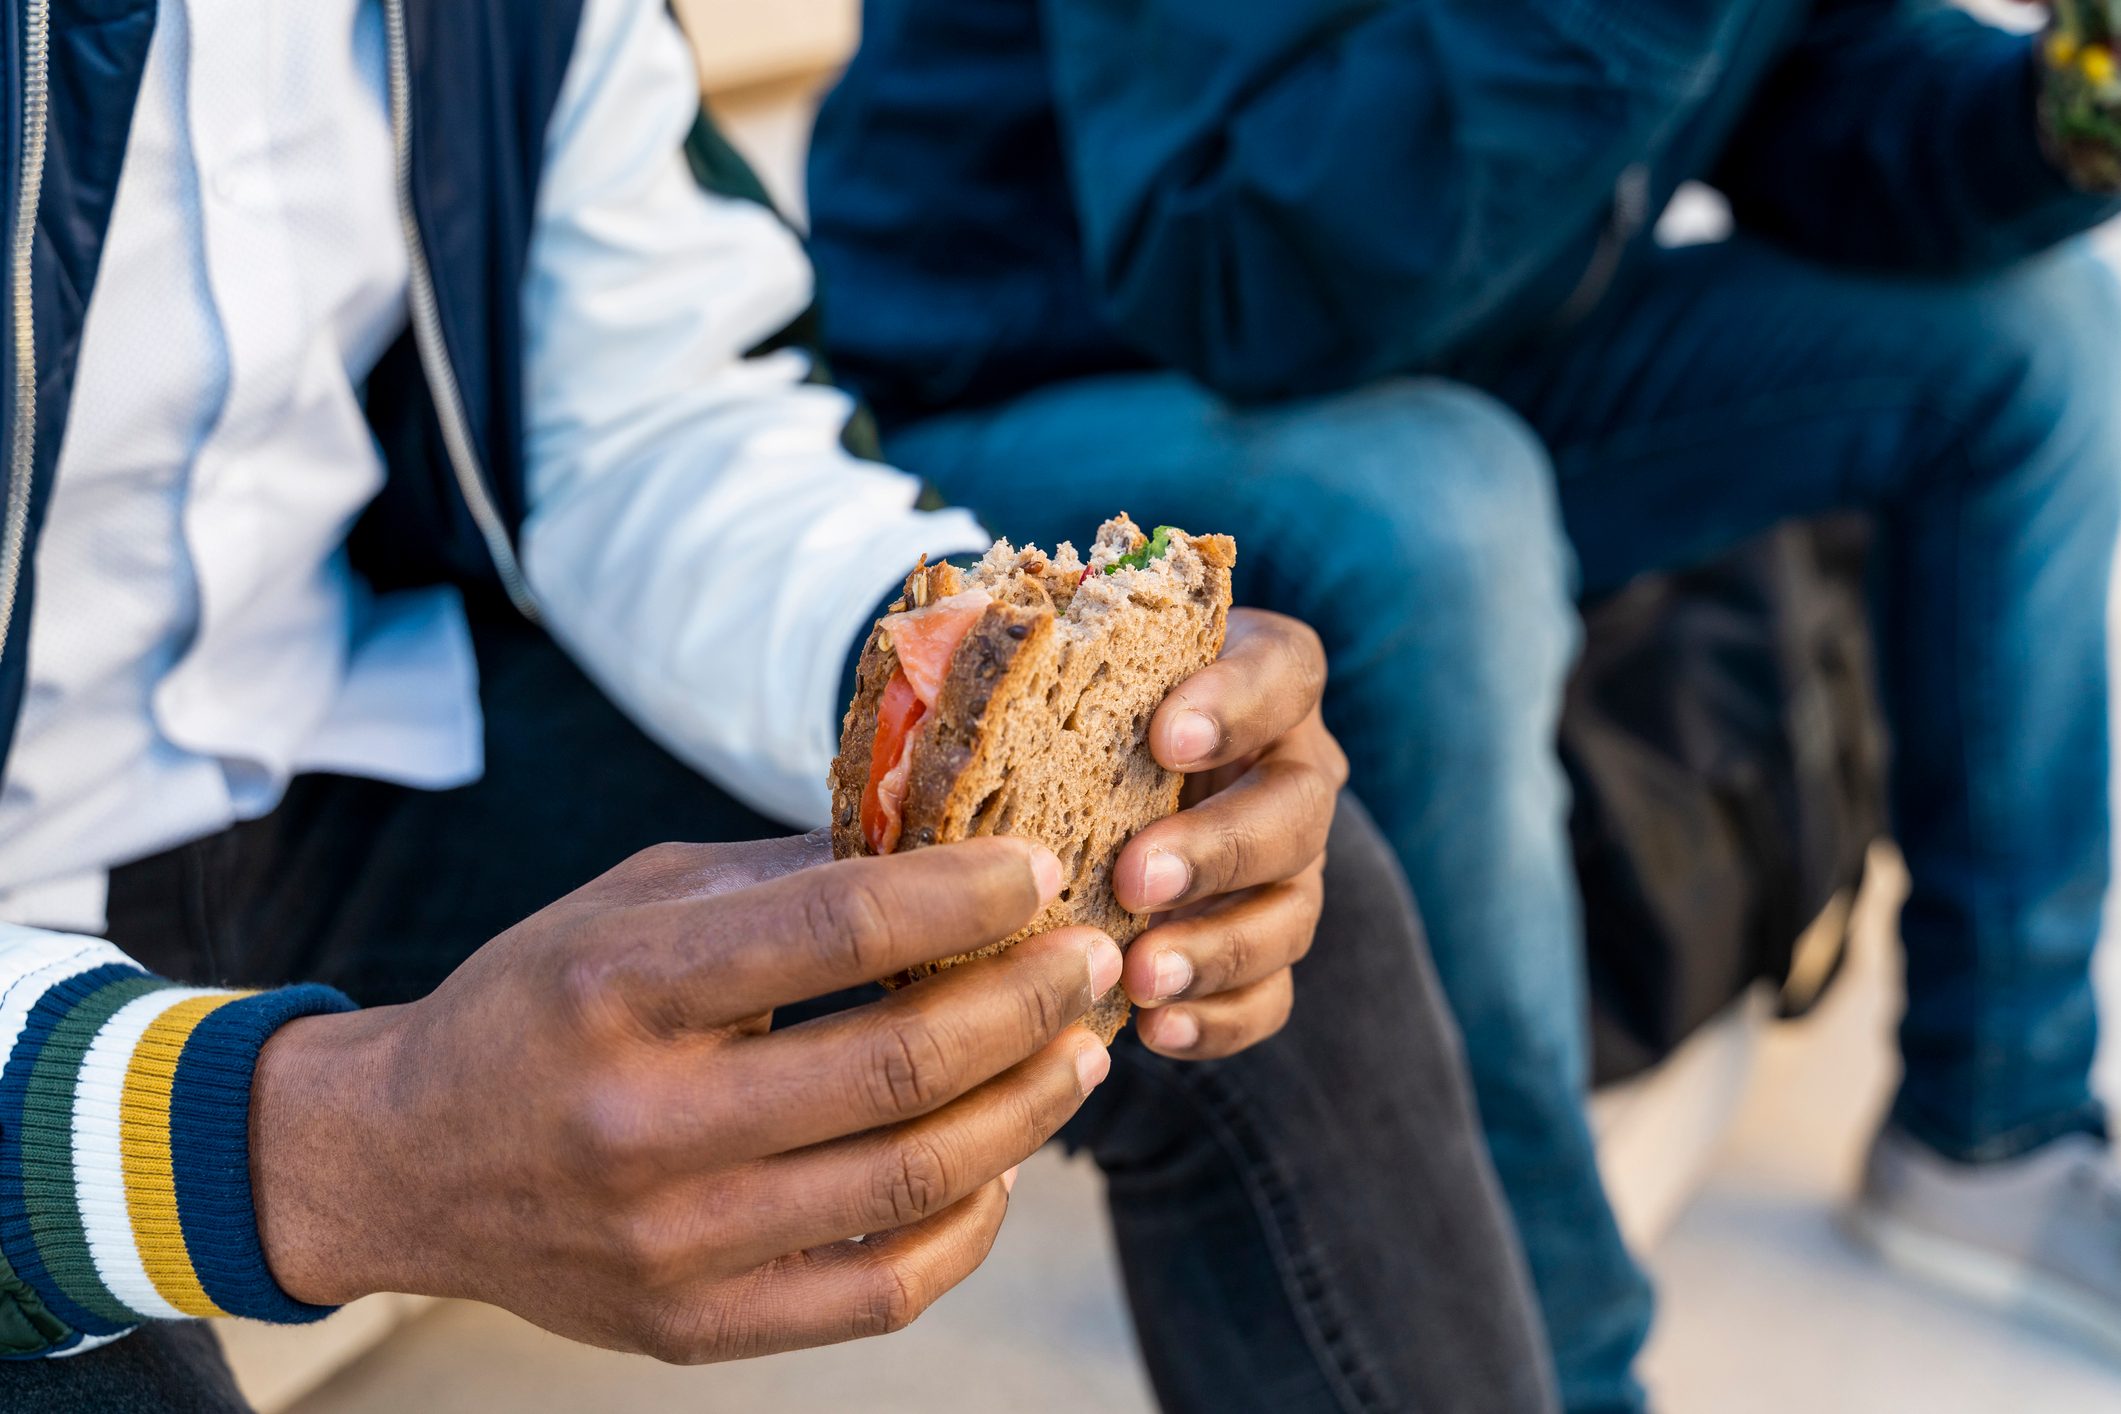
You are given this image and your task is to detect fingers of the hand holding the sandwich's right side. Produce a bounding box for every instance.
[1114,608,1347,1060]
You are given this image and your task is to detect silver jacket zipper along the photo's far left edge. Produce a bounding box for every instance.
[0,0,51,657]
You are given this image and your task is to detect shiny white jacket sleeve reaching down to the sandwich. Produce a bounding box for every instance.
[524,0,988,827]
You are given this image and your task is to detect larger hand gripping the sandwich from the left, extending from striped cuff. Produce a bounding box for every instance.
[250,839,1120,1363]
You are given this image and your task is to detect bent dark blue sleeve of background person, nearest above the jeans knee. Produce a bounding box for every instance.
[1046,0,1739,396]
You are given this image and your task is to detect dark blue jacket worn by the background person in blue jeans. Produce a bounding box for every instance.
[810,0,2110,422]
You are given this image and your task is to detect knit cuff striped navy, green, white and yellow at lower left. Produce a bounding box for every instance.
[0,935,352,1355]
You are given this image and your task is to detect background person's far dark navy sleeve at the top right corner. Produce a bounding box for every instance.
[1716,0,2121,271]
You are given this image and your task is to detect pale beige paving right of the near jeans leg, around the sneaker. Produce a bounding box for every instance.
[1646,869,2121,1414]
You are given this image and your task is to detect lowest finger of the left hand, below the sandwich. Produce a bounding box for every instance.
[643,1181,1010,1365]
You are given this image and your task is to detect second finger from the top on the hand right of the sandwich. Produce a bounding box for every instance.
[1111,753,1338,914]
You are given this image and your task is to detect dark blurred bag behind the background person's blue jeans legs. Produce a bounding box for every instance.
[1561,517,1886,1083]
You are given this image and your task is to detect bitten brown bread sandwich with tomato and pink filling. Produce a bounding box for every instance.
[831,515,1237,1043]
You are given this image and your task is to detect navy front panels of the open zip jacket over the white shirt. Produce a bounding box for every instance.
[0,0,581,775]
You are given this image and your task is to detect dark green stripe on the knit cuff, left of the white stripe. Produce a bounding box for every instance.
[21,975,174,1325]
